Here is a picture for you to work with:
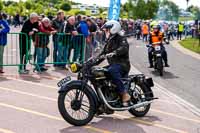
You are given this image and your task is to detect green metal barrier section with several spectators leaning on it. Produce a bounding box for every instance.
[29,33,85,72]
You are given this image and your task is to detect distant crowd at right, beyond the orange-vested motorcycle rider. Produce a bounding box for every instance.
[122,19,200,41]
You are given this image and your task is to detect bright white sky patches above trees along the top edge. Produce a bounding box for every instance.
[73,0,200,9]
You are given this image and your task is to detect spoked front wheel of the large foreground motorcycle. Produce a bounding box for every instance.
[58,85,96,126]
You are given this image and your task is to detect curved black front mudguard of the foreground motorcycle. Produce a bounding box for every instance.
[58,80,99,109]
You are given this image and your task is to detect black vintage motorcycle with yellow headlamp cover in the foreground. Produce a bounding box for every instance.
[57,55,156,126]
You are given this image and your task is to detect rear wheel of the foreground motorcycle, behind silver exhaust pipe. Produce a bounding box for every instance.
[128,84,151,117]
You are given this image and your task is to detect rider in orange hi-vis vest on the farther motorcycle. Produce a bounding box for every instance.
[148,25,169,68]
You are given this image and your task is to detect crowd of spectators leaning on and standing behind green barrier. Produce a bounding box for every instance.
[20,11,109,73]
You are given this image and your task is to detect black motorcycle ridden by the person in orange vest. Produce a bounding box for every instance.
[147,42,164,76]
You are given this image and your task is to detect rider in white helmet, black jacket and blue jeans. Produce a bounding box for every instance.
[100,20,131,106]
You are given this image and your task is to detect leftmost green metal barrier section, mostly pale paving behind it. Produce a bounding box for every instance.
[0,33,29,70]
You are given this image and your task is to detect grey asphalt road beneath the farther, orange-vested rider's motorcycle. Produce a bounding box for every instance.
[129,38,200,108]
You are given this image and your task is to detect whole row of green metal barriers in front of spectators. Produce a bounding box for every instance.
[0,33,85,73]
